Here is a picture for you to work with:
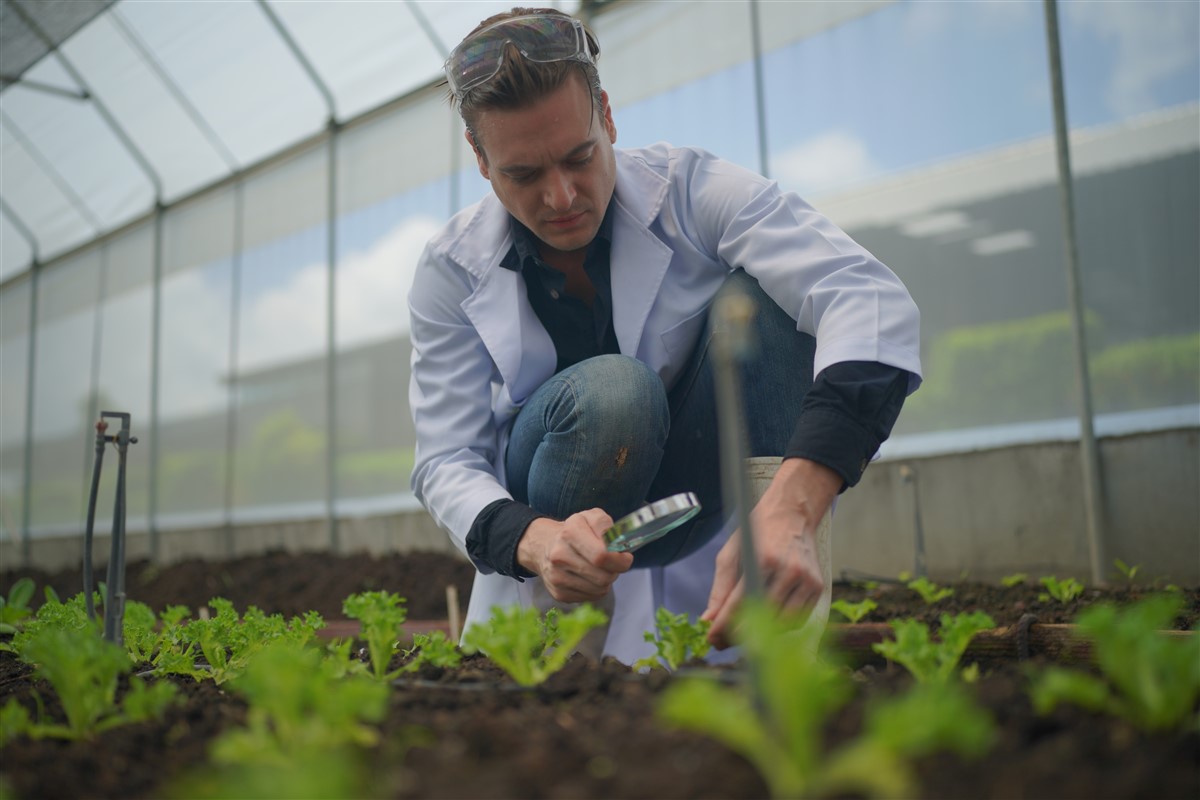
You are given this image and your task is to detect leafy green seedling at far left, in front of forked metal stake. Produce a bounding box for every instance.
[0,627,175,739]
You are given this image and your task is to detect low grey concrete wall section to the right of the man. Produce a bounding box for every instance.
[833,428,1200,584]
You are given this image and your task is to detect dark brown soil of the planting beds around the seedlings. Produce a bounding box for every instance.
[0,554,1200,800]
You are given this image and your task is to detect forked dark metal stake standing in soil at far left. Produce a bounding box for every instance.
[83,411,138,644]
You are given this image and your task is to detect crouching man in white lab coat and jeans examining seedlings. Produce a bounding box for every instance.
[409,8,920,662]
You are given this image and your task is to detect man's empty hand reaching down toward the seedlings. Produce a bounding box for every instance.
[701,458,842,650]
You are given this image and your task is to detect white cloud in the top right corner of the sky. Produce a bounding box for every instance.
[1064,2,1200,116]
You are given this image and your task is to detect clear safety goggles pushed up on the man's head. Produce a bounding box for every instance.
[444,14,595,101]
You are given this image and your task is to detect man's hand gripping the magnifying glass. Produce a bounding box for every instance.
[517,509,634,603]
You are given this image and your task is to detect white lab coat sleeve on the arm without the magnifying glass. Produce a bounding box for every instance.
[668,149,920,392]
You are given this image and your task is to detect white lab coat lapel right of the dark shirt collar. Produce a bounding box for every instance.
[610,150,672,359]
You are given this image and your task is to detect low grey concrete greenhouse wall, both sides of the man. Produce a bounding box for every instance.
[0,428,1200,585]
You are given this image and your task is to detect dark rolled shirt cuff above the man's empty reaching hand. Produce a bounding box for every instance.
[784,361,908,492]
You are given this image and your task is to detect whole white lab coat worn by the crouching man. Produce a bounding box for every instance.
[409,143,920,663]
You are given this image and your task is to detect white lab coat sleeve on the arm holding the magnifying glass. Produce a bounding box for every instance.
[408,248,511,563]
